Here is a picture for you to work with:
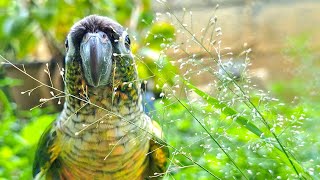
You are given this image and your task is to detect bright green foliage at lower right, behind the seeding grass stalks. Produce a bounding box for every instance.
[151,32,320,179]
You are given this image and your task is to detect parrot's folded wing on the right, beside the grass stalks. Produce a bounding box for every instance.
[148,121,169,177]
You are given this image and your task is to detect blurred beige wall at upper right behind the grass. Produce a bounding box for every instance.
[153,0,320,83]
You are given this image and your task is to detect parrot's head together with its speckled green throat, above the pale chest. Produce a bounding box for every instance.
[64,15,141,108]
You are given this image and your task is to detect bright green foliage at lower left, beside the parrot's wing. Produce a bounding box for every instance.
[0,79,56,179]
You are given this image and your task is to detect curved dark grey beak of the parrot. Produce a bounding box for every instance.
[80,31,112,87]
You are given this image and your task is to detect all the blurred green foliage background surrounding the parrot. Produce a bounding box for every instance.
[0,0,320,179]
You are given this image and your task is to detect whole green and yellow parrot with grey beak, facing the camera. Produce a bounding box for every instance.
[33,15,169,180]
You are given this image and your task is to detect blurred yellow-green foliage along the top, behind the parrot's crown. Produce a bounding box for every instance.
[0,0,173,60]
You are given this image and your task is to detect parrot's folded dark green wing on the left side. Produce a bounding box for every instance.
[33,123,60,179]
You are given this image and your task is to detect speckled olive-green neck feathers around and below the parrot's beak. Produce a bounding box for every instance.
[65,55,141,114]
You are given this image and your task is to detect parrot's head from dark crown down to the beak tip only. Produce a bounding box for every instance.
[65,15,135,87]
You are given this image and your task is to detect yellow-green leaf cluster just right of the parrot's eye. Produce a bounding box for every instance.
[137,22,177,93]
